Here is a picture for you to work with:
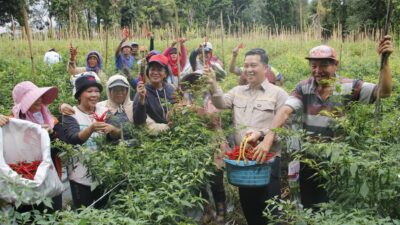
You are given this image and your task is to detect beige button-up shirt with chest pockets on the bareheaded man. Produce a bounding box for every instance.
[211,79,288,155]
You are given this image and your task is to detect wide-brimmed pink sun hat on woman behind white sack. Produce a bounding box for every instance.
[12,81,58,115]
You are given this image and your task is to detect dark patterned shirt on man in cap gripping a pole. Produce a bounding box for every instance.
[285,76,376,137]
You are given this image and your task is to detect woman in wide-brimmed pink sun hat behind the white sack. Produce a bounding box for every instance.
[0,81,63,212]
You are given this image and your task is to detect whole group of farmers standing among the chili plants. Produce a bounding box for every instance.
[0,32,393,225]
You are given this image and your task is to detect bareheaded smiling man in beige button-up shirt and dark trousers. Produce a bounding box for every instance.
[208,48,288,225]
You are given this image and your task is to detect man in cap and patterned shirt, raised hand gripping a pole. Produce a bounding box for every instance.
[254,36,393,208]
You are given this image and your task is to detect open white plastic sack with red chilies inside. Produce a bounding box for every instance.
[0,119,63,204]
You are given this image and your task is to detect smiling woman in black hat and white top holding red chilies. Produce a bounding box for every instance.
[63,75,121,208]
